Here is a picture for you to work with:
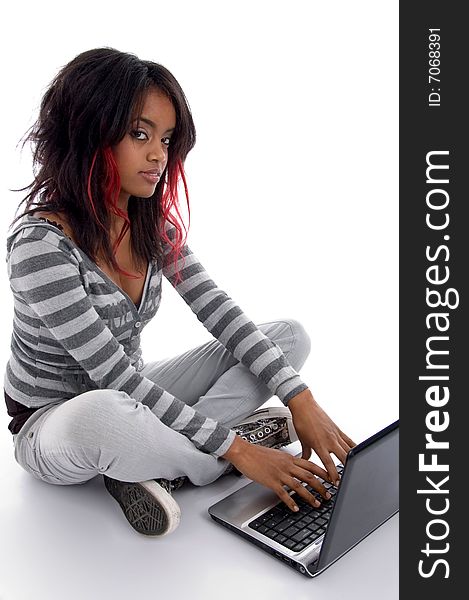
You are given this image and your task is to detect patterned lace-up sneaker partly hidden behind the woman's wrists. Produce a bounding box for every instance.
[232,406,298,448]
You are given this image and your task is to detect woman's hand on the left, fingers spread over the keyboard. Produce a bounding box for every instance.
[222,435,330,511]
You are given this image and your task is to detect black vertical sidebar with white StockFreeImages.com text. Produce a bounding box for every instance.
[399,0,469,600]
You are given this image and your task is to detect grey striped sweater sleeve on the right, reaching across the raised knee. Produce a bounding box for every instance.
[163,223,308,405]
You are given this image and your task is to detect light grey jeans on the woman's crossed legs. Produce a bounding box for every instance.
[14,319,311,485]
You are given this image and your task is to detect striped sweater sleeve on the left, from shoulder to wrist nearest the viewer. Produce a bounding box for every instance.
[8,233,236,457]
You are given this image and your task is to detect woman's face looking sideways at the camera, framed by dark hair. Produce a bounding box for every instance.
[112,89,176,209]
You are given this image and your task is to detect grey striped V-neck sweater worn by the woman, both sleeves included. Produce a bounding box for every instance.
[4,216,307,456]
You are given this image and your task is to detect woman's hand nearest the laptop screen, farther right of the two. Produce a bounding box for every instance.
[288,389,356,485]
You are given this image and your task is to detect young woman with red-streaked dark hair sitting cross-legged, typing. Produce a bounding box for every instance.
[4,48,354,535]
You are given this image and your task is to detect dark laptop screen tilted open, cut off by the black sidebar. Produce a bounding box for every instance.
[314,421,399,570]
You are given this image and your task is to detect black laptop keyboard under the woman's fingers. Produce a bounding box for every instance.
[249,465,344,552]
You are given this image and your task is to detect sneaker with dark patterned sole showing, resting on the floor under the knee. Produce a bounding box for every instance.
[104,475,181,536]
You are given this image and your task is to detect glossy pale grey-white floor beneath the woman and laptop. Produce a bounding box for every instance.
[0,418,399,600]
